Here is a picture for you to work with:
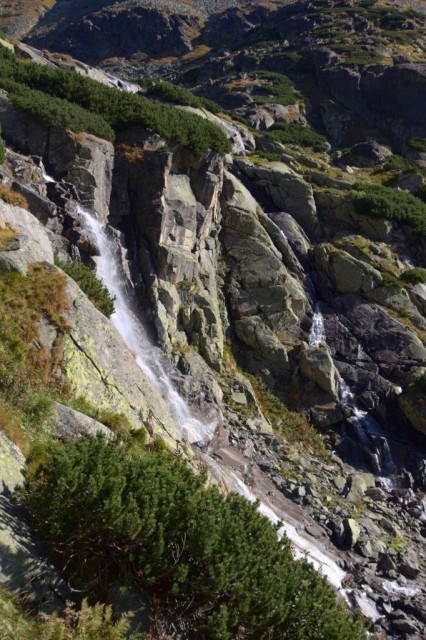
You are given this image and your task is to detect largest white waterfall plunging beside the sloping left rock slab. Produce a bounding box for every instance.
[77,205,213,443]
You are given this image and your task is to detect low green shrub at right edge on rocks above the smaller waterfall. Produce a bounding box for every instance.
[352,184,426,236]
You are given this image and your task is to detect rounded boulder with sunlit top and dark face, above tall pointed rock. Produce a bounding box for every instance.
[236,158,319,239]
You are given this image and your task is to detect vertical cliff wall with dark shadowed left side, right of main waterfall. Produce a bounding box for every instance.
[112,140,223,368]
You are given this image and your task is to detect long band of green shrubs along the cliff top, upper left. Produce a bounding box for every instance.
[0,48,231,155]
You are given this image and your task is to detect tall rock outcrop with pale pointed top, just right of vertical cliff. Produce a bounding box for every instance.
[221,172,310,379]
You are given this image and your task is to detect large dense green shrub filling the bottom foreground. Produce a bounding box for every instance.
[22,438,365,640]
